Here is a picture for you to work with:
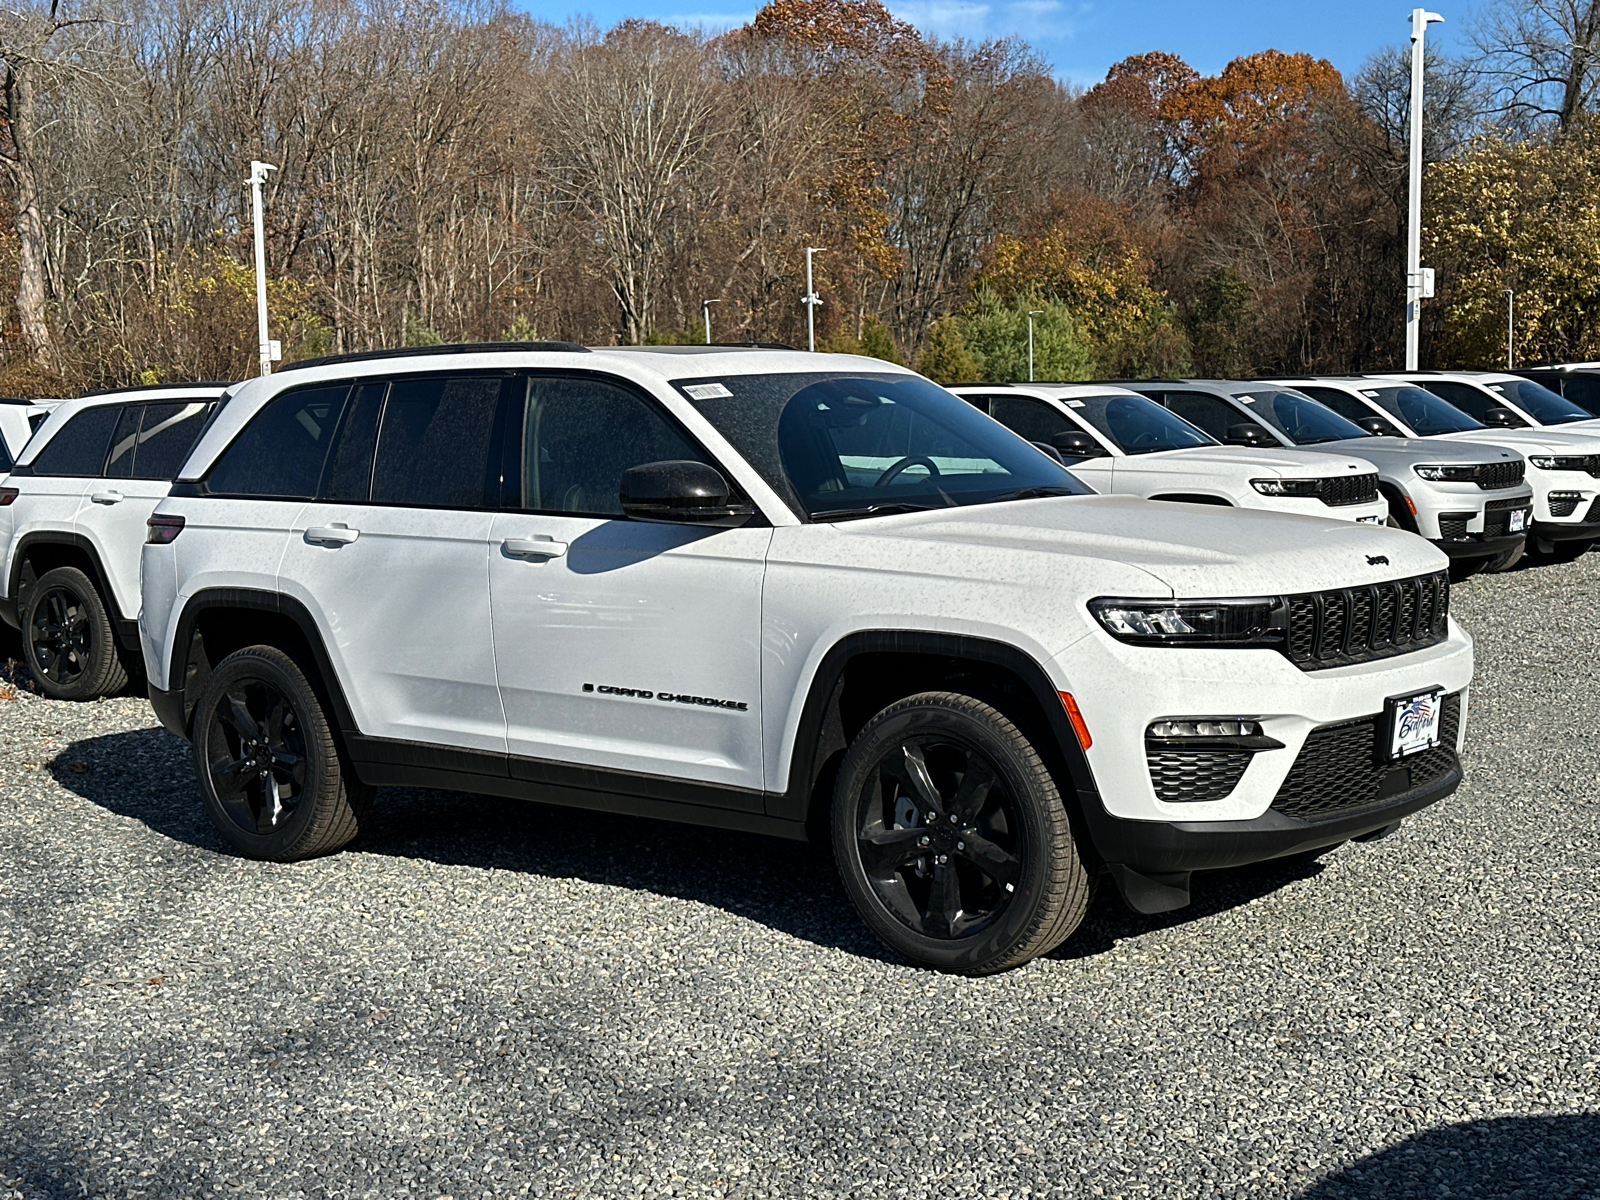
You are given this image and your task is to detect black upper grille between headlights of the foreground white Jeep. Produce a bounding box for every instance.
[1286,571,1450,670]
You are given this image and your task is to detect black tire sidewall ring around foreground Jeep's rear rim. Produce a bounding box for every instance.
[190,646,338,862]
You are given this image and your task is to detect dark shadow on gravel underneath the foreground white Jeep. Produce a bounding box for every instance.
[48,728,1320,962]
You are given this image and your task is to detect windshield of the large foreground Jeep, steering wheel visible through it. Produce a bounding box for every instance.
[674,371,1090,520]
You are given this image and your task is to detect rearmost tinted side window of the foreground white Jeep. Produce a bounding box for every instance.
[206,384,350,499]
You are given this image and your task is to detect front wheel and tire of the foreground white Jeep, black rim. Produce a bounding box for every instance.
[832,691,1090,974]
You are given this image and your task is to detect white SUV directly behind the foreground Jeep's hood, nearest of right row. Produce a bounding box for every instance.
[950,384,1389,525]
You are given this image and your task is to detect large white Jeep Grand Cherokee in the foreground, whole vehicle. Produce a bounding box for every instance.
[139,342,1472,973]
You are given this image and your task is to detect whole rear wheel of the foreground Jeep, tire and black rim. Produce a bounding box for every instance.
[190,646,371,862]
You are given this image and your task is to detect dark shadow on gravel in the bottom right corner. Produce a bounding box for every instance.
[1299,1114,1600,1200]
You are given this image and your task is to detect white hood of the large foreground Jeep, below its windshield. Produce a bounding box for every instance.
[835,496,1448,598]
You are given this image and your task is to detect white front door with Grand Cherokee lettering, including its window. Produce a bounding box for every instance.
[490,376,771,811]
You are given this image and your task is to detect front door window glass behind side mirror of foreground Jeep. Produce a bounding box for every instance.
[520,376,715,517]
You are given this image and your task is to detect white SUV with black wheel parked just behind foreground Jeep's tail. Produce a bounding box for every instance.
[0,384,224,699]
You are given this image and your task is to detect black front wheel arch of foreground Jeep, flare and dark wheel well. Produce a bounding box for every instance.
[768,630,1099,851]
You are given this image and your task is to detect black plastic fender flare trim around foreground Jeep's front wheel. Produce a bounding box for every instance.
[766,629,1102,821]
